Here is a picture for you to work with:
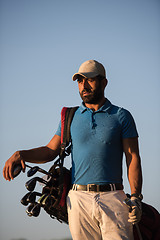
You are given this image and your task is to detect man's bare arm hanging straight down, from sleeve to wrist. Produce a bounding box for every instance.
[123,138,142,195]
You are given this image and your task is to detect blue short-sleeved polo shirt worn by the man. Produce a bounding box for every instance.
[56,99,138,185]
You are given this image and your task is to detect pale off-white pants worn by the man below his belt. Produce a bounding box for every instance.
[67,190,133,240]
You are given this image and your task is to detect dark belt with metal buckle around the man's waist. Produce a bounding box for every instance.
[72,183,123,192]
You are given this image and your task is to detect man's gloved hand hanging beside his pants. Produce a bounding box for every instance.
[127,197,142,224]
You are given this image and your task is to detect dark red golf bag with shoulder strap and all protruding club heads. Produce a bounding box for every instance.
[20,107,78,224]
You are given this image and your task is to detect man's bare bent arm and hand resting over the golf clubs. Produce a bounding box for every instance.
[3,135,61,181]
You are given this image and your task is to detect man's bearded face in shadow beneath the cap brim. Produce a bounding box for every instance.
[77,76,104,104]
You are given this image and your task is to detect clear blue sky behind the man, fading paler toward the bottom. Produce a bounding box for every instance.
[0,0,160,240]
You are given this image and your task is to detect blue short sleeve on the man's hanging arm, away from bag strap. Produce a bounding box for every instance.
[119,108,138,138]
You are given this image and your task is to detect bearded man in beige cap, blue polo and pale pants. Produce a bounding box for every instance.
[3,60,142,240]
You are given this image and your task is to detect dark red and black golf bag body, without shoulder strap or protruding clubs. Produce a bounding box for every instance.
[40,163,71,223]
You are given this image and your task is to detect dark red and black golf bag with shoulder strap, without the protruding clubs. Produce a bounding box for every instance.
[41,107,78,223]
